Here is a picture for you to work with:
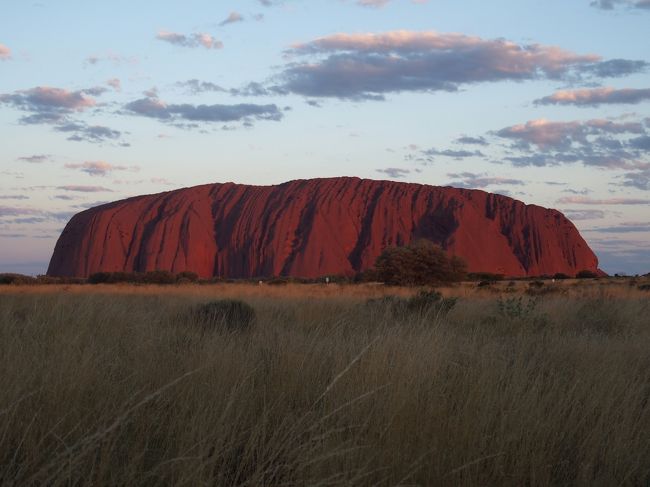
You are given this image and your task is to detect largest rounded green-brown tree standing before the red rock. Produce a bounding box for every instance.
[375,240,467,286]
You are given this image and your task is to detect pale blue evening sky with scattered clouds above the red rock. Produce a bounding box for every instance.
[0,0,650,275]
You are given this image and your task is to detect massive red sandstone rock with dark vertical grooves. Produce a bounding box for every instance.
[48,178,598,278]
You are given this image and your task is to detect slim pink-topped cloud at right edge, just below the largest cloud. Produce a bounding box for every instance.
[535,88,650,107]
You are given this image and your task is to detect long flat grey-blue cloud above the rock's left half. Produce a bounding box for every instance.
[125,97,283,123]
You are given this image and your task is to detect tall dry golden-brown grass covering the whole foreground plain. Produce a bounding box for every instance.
[0,283,650,486]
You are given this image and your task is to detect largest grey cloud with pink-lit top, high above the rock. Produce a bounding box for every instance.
[277,31,647,100]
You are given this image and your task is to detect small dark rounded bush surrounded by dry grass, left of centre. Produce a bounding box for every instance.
[194,299,256,331]
